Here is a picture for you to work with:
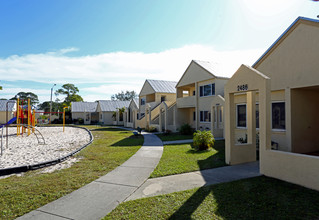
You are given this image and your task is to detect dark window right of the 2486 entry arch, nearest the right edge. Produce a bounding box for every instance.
[271,102,286,130]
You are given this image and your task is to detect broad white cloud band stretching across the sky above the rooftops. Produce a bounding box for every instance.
[0,45,263,101]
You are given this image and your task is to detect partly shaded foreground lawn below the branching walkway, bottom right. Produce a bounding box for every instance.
[104,176,319,220]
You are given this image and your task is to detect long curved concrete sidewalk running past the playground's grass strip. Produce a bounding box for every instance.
[18,133,163,220]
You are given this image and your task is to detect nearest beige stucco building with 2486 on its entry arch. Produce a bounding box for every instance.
[225,17,319,190]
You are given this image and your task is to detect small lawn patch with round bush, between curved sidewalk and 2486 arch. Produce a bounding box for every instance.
[151,141,226,178]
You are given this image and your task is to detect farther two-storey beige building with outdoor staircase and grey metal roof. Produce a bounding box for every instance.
[134,79,176,131]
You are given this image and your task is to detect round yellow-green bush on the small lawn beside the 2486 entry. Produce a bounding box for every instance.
[193,131,215,150]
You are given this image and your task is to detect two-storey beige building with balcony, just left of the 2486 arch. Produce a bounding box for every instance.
[176,60,228,138]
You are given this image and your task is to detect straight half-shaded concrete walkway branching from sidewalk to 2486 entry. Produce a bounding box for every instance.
[126,162,261,201]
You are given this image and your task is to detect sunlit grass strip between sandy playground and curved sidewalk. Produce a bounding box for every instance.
[0,126,143,219]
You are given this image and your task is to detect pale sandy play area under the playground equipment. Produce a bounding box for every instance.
[0,127,90,169]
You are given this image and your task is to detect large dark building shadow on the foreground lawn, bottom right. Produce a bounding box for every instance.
[169,176,319,219]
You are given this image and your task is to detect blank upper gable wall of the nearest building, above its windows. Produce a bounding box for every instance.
[255,22,319,90]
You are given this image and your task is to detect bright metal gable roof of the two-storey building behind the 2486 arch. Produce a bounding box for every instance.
[176,60,229,87]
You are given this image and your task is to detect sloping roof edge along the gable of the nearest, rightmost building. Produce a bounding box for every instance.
[252,17,319,68]
